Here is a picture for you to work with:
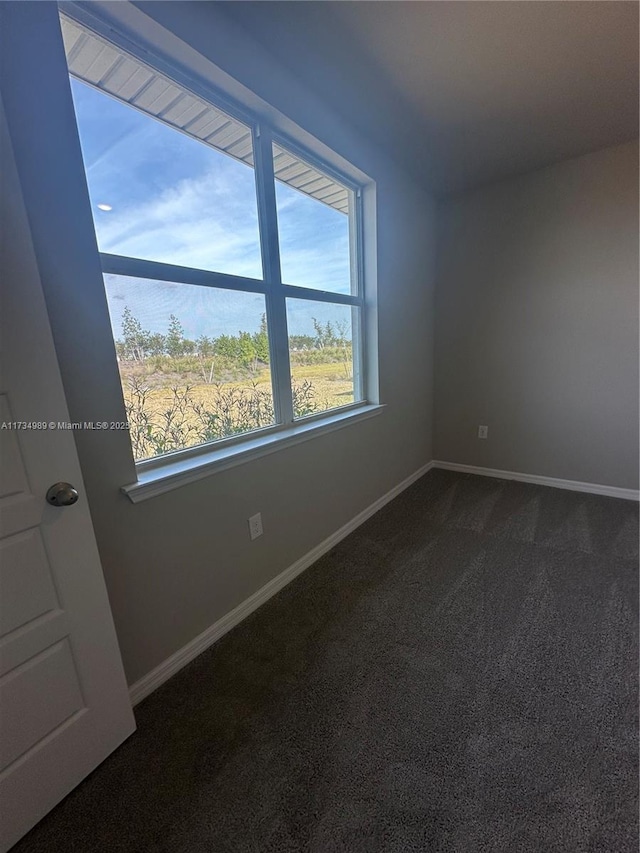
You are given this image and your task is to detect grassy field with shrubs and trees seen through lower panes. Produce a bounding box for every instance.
[116,307,354,461]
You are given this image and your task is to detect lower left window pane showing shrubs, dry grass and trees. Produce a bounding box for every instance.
[104,275,274,461]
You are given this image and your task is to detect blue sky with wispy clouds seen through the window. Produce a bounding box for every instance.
[72,79,350,339]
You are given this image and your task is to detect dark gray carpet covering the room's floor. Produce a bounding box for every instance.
[14,471,638,853]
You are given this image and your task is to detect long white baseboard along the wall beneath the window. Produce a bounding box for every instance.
[129,462,434,705]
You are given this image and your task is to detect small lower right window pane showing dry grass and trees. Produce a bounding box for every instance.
[287,299,360,418]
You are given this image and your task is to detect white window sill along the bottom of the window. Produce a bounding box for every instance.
[121,404,384,503]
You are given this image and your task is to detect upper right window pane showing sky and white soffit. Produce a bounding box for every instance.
[273,145,355,293]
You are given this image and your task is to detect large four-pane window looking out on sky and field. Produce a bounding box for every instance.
[62,11,366,462]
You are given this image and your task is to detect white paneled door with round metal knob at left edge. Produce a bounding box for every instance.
[0,95,135,853]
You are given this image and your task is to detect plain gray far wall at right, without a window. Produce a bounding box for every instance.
[434,143,638,489]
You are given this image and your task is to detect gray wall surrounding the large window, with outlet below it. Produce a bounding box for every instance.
[0,3,434,682]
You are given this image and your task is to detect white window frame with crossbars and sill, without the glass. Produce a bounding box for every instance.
[60,3,384,503]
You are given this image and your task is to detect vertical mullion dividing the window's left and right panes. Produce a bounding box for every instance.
[254,127,293,424]
